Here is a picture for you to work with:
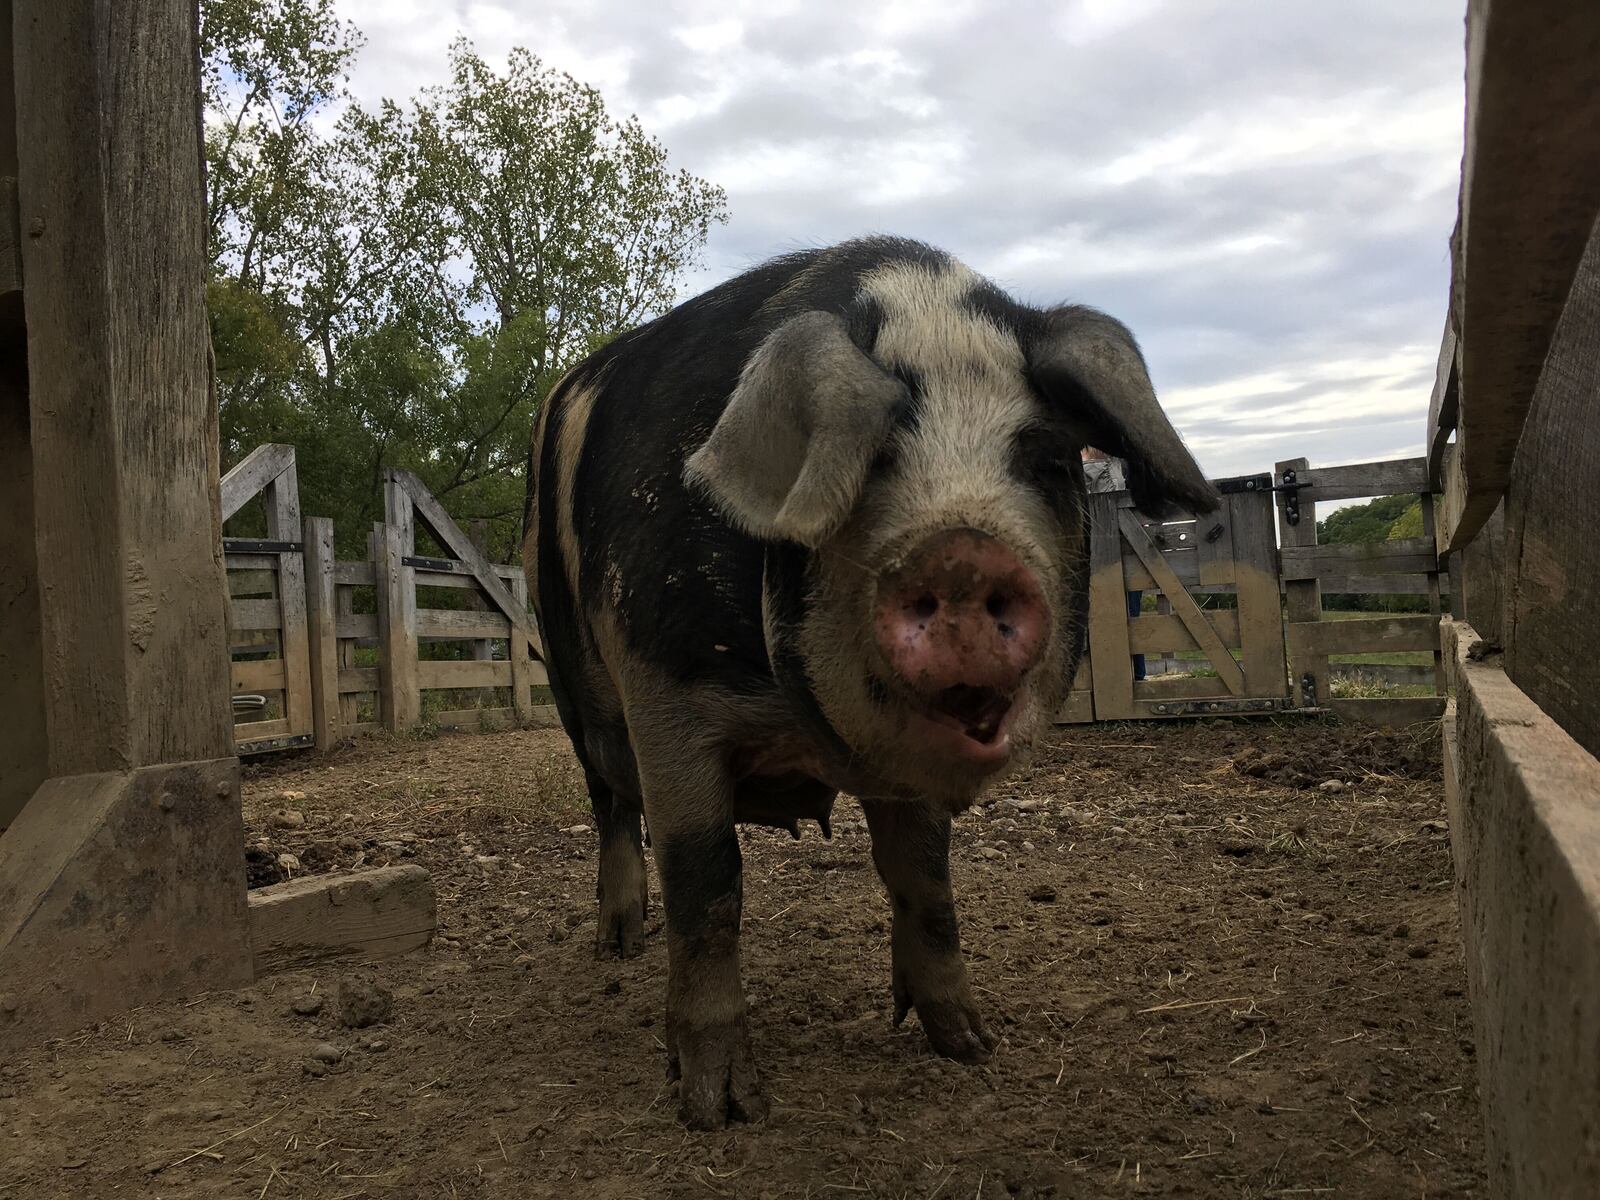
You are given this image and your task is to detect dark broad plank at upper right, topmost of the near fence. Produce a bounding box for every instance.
[1445,0,1600,550]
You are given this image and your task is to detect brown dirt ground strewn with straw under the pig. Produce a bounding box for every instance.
[0,722,1483,1200]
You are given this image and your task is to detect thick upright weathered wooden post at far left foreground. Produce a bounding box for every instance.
[6,0,234,774]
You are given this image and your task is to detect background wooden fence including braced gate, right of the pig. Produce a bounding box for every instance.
[1061,458,1445,725]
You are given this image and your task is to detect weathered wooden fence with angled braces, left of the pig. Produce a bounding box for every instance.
[222,445,555,754]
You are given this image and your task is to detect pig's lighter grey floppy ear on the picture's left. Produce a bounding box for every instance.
[683,312,906,549]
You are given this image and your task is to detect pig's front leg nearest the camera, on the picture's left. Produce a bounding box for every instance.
[640,742,766,1130]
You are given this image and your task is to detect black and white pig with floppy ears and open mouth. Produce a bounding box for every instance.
[523,238,1216,1128]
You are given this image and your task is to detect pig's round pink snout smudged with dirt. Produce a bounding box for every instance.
[874,528,1050,704]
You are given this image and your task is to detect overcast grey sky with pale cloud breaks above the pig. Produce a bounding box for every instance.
[341,0,1466,489]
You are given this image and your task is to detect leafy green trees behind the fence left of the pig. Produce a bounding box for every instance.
[202,0,726,560]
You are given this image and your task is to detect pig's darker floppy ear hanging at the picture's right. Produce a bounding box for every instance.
[1027,307,1218,517]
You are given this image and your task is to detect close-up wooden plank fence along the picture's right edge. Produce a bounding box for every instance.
[1426,0,1600,1197]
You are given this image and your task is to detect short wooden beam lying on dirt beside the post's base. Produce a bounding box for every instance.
[250,864,438,979]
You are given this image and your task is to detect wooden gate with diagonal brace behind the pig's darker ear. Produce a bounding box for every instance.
[1061,475,1293,722]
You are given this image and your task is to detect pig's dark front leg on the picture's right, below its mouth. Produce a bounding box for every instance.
[861,800,997,1062]
